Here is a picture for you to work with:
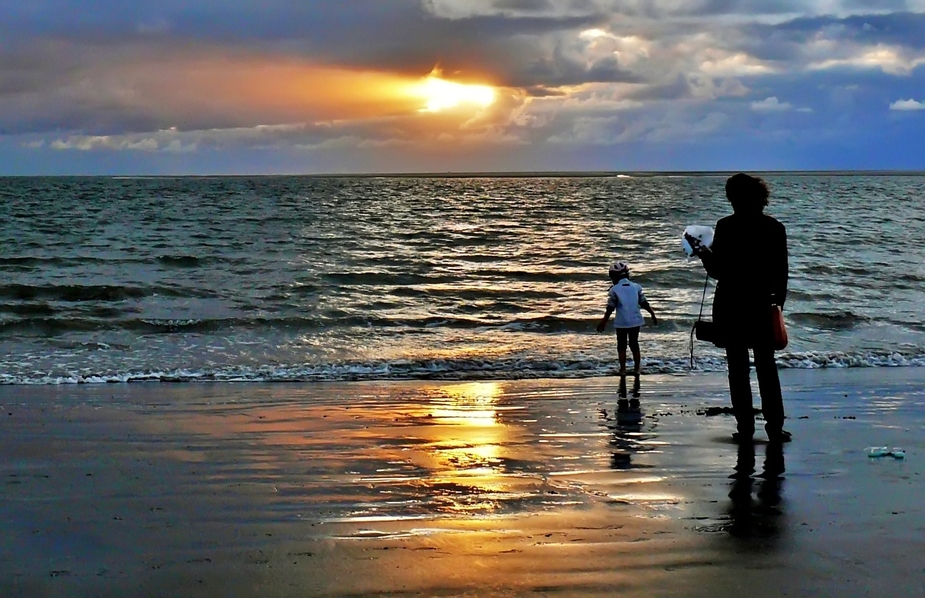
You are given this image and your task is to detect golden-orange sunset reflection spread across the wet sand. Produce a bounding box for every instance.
[113,378,680,523]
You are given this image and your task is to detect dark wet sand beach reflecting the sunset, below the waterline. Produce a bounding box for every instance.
[0,368,925,597]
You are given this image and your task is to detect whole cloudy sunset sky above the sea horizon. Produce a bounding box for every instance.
[0,0,925,174]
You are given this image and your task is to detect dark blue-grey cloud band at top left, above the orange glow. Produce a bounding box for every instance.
[0,0,618,85]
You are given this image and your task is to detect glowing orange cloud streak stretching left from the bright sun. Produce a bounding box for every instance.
[32,44,506,132]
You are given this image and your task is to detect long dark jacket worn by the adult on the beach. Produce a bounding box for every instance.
[703,213,789,348]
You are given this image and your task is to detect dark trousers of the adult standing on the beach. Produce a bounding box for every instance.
[726,347,784,435]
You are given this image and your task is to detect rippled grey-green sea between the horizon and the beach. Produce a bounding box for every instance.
[0,172,925,385]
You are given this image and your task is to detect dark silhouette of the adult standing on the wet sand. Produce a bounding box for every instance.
[687,173,791,442]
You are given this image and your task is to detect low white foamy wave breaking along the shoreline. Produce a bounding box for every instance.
[0,351,925,385]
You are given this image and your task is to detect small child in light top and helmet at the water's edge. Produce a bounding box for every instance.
[597,262,658,376]
